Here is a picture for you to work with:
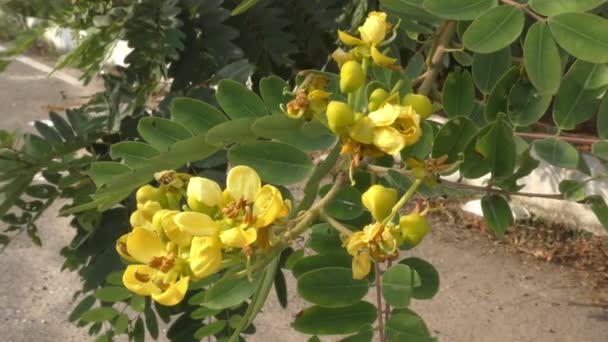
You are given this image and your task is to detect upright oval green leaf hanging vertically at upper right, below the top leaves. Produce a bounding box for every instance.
[524,22,562,94]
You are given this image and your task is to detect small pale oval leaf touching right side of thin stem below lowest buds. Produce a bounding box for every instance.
[382,264,414,308]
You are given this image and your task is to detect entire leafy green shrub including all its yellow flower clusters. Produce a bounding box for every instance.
[0,0,608,341]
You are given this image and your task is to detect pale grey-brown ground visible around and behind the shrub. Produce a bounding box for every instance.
[0,53,608,342]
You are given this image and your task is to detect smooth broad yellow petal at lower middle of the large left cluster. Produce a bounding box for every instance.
[188,236,222,279]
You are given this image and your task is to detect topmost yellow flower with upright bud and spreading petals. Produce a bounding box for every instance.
[332,12,397,67]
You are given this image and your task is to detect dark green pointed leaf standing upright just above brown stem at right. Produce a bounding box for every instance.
[475,114,517,178]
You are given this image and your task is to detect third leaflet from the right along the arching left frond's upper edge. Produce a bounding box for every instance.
[171,97,228,135]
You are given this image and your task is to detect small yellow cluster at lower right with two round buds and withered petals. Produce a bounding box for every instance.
[344,185,429,279]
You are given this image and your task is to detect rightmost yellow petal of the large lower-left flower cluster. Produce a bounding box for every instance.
[253,185,289,228]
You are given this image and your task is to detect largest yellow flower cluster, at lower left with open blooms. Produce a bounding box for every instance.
[116,166,291,306]
